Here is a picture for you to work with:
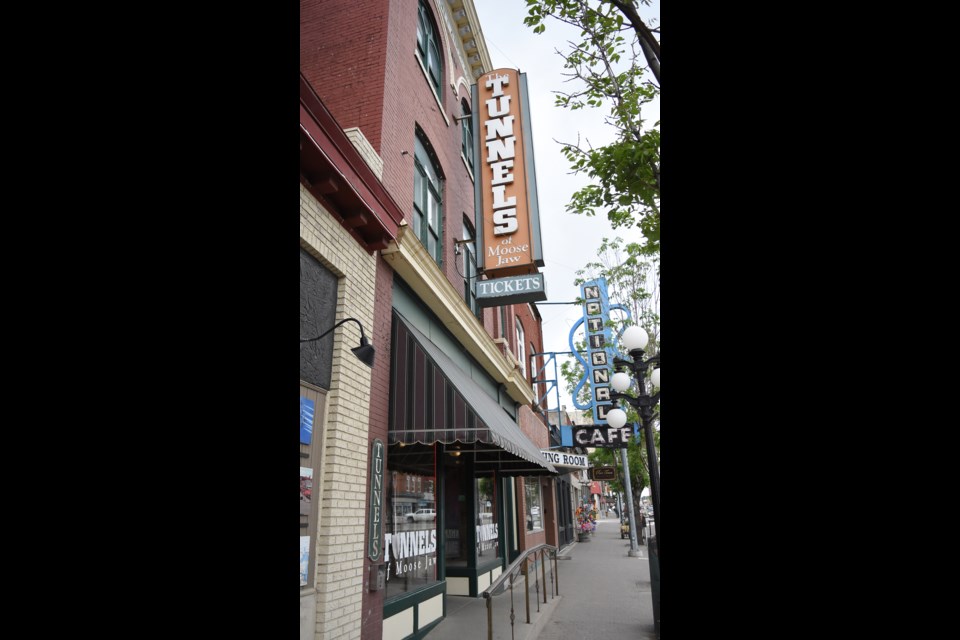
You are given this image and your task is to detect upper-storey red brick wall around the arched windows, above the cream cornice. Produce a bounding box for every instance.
[300,0,494,337]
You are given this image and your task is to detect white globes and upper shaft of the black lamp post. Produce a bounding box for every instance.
[607,327,660,558]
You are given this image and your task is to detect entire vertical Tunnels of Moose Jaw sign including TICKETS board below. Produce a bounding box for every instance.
[472,69,547,306]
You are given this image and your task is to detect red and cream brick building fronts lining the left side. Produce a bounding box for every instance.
[300,0,558,640]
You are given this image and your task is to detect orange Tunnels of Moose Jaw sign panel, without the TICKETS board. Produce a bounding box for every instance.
[475,69,539,278]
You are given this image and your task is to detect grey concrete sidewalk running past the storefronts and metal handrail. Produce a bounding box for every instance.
[426,517,656,640]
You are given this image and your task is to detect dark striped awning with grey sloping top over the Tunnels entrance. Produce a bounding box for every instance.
[389,311,559,475]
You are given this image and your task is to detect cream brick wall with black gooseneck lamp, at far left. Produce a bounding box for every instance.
[300,185,384,640]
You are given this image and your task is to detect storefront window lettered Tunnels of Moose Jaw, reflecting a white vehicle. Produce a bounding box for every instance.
[384,464,437,598]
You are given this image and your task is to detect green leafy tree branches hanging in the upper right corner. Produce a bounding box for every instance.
[524,0,660,252]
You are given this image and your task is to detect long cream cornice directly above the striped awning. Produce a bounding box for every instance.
[380,221,535,405]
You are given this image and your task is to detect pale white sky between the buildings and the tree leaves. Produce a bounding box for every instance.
[474,0,660,410]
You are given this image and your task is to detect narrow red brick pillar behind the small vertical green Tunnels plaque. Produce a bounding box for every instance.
[360,257,393,640]
